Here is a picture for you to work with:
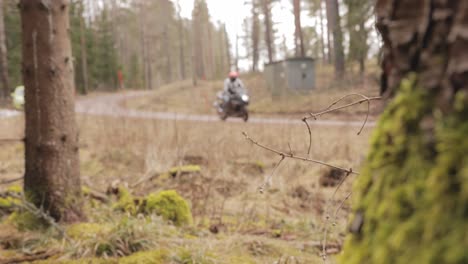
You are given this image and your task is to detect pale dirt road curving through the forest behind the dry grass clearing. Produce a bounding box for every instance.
[0,91,374,126]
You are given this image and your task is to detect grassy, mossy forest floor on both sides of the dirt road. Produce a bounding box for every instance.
[0,65,376,263]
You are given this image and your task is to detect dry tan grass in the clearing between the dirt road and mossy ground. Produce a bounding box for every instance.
[0,105,370,263]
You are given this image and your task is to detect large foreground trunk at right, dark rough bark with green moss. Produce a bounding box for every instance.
[341,0,468,264]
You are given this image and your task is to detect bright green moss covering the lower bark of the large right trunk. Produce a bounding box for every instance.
[341,76,468,264]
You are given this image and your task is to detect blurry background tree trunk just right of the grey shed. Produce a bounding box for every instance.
[326,0,345,76]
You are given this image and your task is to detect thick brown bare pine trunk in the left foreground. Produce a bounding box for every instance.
[20,0,84,222]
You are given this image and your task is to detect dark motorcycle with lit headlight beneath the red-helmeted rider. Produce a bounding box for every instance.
[214,91,250,122]
